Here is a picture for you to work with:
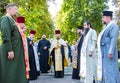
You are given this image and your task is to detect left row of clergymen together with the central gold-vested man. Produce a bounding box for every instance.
[0,3,68,83]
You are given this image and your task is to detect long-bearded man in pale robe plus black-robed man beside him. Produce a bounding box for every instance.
[72,22,97,83]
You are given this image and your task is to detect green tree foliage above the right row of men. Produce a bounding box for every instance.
[56,0,106,43]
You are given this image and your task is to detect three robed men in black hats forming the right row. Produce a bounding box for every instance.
[72,11,120,83]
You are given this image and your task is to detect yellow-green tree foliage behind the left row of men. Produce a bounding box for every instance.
[0,0,54,42]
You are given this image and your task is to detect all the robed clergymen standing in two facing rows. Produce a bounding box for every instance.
[0,3,120,83]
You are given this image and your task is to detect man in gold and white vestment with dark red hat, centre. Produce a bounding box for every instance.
[50,30,68,78]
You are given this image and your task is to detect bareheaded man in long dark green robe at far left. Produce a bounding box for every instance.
[0,3,27,83]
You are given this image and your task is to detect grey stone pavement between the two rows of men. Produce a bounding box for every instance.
[30,66,80,83]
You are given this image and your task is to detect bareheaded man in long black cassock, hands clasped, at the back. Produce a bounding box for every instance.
[38,34,50,73]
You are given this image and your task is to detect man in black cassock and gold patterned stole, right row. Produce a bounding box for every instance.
[72,26,83,79]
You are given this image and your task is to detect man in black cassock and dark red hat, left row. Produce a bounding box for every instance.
[27,30,37,80]
